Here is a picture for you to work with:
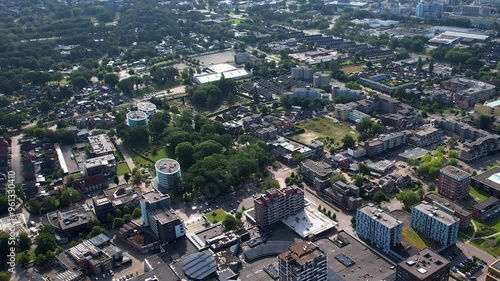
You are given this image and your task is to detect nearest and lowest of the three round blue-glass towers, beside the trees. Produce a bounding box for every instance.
[155,158,181,192]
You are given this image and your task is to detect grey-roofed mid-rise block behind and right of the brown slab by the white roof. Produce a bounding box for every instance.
[299,159,333,190]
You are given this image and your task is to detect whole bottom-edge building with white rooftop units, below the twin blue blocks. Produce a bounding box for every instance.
[396,248,451,281]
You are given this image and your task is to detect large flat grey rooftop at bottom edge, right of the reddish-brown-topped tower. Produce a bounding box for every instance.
[314,231,396,281]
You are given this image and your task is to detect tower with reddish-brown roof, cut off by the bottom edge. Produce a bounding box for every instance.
[278,241,328,281]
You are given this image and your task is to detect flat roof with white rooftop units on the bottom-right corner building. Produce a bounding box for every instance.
[398,248,450,280]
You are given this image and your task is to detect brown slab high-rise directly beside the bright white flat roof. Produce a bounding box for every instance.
[254,186,304,227]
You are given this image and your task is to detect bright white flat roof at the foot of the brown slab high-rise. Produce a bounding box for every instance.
[282,206,337,237]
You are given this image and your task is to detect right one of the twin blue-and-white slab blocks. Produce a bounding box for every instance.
[411,201,460,249]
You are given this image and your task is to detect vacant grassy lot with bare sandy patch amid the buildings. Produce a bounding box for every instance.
[292,117,359,148]
